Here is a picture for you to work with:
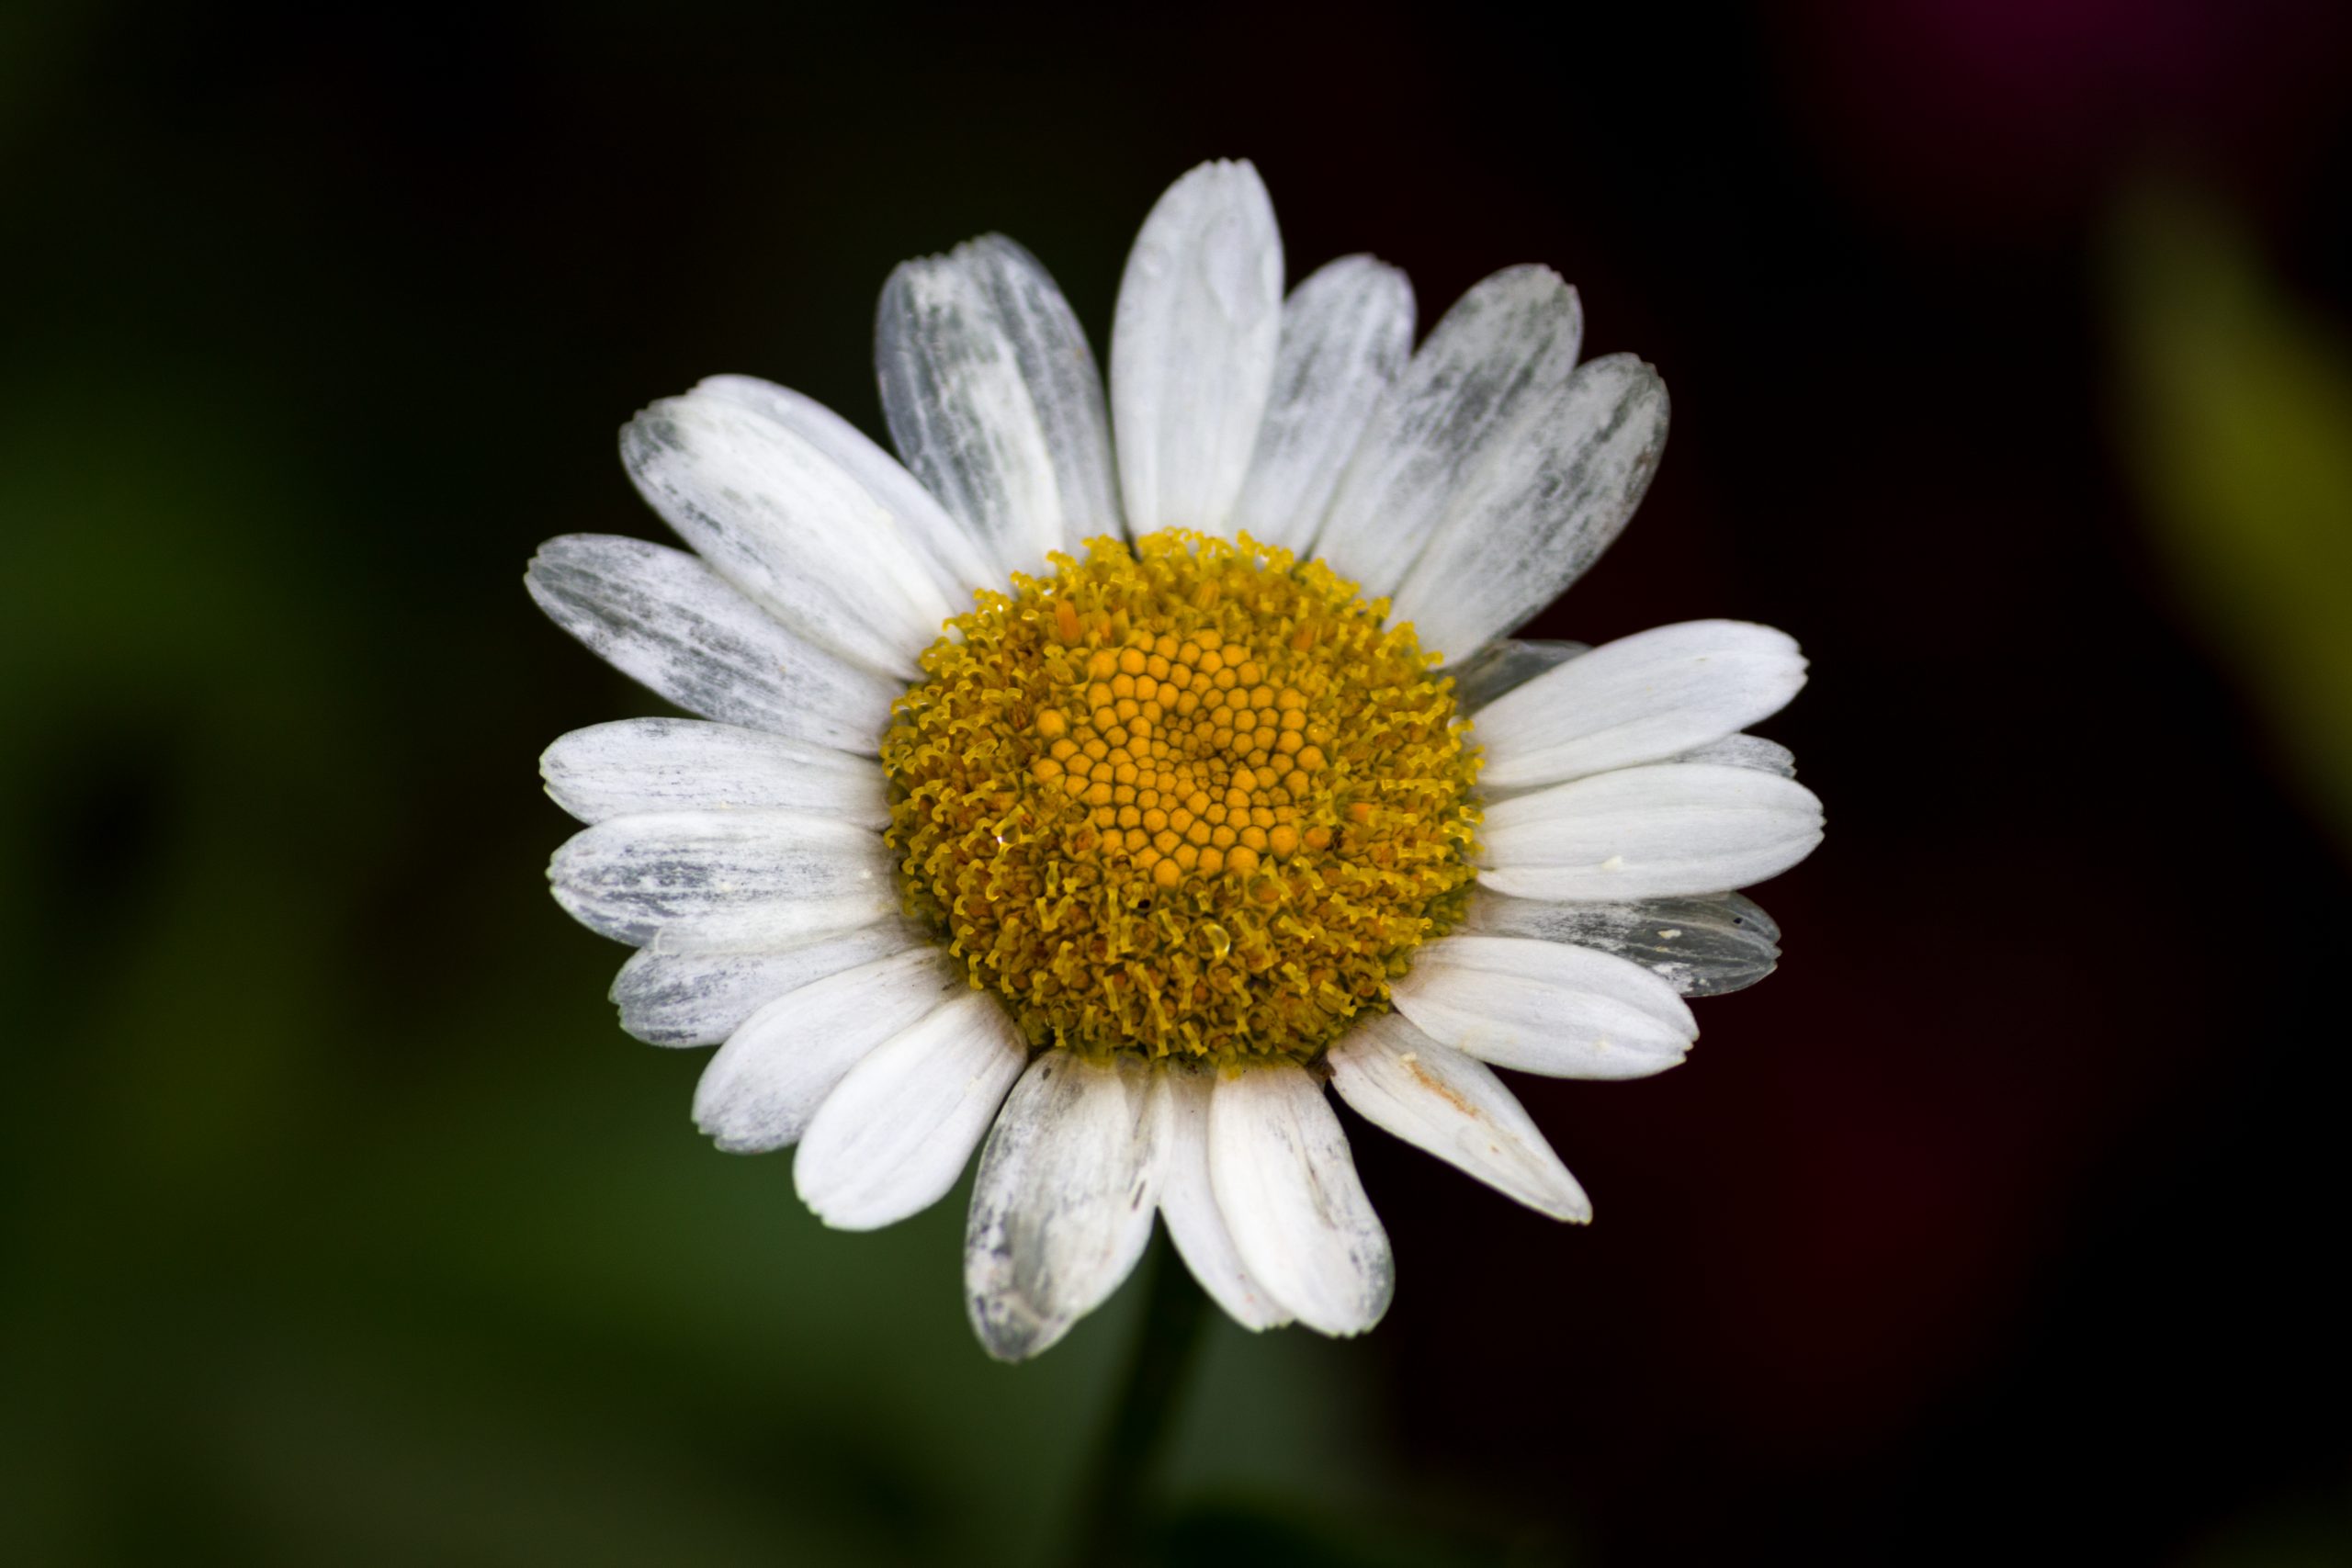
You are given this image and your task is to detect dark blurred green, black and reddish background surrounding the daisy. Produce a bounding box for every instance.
[0,0,2352,1568]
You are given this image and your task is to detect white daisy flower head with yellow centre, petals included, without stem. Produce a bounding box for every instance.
[529,163,1820,1359]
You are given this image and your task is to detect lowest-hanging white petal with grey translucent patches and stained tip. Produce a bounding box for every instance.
[965,1051,1159,1361]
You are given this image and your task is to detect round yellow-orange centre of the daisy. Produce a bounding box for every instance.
[882,531,1477,1065]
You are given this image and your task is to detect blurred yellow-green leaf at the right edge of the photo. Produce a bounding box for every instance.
[2108,181,2352,849]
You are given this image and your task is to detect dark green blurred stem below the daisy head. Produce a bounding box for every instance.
[1068,1236,1209,1568]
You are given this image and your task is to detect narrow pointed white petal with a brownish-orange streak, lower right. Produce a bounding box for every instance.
[1329,1013,1592,1223]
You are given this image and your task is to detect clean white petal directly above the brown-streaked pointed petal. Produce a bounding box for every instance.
[1390,936,1698,1079]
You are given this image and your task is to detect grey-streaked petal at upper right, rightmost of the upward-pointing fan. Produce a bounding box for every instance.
[1390,355,1665,651]
